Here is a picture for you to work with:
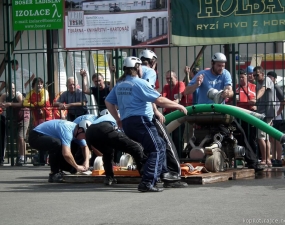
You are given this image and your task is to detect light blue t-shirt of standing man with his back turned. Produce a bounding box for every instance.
[106,76,160,121]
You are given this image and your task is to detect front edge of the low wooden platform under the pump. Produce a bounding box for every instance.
[64,169,255,184]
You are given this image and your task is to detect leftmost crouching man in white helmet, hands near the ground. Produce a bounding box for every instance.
[29,120,91,183]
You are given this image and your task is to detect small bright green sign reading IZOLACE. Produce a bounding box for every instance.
[12,0,64,30]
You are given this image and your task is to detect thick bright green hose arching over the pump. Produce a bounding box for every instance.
[165,104,285,144]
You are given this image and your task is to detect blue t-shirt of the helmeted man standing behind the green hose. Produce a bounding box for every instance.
[188,69,232,104]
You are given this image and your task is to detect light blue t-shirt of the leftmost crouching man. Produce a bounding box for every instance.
[34,120,87,147]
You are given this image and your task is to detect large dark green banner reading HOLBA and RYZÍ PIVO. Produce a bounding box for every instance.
[171,0,285,46]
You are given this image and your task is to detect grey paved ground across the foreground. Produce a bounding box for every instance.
[0,166,285,225]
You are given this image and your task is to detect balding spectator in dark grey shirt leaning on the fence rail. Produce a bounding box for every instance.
[54,77,89,121]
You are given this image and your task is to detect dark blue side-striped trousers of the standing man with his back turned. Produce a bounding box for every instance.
[122,116,168,187]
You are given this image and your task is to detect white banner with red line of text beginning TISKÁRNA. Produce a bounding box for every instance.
[65,11,168,49]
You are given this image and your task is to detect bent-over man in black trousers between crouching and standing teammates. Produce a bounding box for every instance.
[86,111,144,185]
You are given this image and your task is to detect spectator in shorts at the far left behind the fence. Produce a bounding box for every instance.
[0,83,30,166]
